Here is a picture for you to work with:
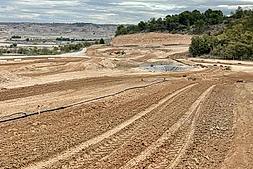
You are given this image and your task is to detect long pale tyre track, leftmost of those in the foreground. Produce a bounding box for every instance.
[25,84,196,169]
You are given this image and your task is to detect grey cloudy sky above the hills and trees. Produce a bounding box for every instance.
[0,0,253,24]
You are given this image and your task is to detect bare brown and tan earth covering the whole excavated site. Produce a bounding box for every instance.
[0,34,253,169]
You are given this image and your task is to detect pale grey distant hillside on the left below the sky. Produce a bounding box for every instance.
[0,22,118,39]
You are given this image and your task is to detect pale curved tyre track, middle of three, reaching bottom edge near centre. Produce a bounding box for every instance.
[121,85,215,169]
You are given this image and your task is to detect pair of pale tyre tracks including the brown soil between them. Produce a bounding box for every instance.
[26,81,214,169]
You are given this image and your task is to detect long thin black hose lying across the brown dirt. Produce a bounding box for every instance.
[0,78,167,123]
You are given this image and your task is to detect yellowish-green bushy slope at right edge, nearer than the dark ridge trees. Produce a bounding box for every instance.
[189,7,253,60]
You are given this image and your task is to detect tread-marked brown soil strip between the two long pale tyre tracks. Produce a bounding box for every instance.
[67,85,210,169]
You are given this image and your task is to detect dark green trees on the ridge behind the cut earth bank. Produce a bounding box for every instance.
[115,9,224,36]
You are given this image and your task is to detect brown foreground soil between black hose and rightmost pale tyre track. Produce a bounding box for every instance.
[0,76,223,169]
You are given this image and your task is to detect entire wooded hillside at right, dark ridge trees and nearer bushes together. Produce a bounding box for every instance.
[115,7,253,60]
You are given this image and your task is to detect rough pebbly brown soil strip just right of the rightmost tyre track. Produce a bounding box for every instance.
[175,85,237,168]
